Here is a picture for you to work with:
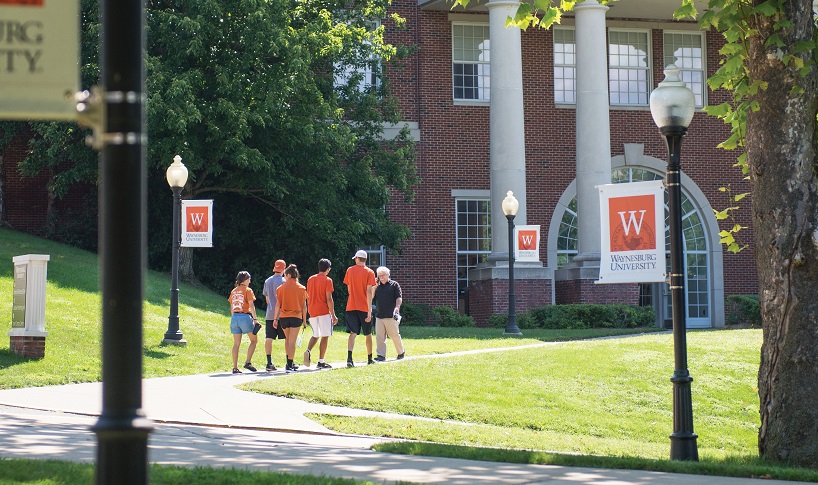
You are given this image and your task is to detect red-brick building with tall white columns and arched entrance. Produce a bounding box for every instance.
[374,0,757,328]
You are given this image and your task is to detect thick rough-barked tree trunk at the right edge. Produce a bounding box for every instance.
[746,0,818,467]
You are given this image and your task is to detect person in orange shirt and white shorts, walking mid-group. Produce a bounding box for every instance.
[304,259,338,369]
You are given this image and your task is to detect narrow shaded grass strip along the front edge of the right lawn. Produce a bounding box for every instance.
[374,442,818,482]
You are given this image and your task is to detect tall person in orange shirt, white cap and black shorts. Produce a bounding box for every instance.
[344,250,376,367]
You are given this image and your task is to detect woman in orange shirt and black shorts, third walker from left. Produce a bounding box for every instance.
[273,264,307,372]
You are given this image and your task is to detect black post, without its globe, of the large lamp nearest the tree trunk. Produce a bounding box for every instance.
[660,126,699,461]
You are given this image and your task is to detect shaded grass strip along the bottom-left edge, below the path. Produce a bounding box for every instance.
[0,458,388,485]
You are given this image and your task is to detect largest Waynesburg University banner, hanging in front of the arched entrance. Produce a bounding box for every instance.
[596,180,666,283]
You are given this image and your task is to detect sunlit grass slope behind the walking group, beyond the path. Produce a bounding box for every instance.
[0,229,644,389]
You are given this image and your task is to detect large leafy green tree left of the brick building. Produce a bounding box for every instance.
[4,0,417,290]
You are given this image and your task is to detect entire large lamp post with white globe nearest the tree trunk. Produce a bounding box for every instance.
[650,65,699,461]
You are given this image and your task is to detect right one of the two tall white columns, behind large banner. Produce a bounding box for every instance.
[574,0,611,266]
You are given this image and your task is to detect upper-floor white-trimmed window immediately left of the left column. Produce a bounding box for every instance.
[452,23,491,101]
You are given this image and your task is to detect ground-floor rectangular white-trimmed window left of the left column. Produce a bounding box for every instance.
[455,198,491,301]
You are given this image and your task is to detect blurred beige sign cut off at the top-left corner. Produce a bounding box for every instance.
[0,0,80,120]
